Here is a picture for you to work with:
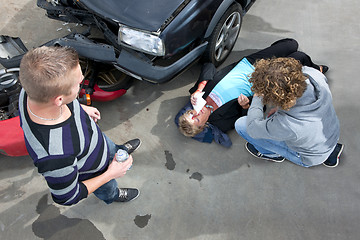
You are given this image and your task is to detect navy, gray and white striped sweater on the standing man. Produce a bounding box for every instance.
[19,89,110,205]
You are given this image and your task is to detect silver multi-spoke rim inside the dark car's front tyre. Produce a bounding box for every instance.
[214,12,241,62]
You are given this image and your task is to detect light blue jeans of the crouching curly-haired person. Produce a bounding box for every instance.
[235,116,310,167]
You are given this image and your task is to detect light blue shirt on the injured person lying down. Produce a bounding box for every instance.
[209,58,255,107]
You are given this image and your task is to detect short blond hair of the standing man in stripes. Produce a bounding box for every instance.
[20,46,79,103]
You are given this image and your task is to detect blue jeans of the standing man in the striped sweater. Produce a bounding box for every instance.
[94,133,126,204]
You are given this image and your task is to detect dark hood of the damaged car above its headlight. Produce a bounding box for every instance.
[80,0,184,32]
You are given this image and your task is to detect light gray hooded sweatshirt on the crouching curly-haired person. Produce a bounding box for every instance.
[247,67,340,165]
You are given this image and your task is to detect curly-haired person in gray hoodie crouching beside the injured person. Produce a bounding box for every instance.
[235,58,344,167]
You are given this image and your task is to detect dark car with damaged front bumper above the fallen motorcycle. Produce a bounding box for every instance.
[37,0,255,83]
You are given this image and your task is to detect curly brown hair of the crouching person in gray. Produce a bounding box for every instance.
[249,58,307,110]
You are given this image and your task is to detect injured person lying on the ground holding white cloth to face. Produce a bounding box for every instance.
[175,38,328,147]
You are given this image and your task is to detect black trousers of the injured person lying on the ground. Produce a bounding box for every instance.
[246,38,320,70]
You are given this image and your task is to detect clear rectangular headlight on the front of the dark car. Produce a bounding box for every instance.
[118,25,165,56]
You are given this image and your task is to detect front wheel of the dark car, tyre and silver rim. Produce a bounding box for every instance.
[203,4,242,67]
